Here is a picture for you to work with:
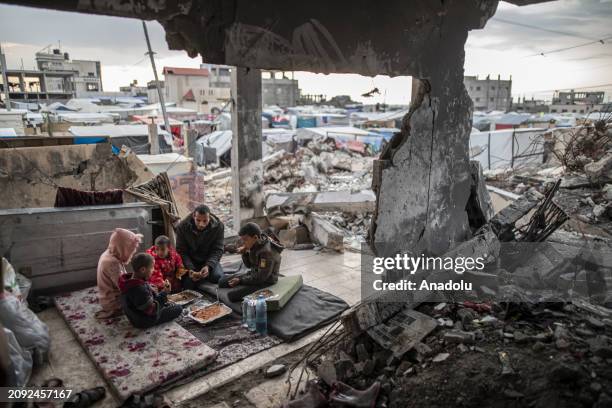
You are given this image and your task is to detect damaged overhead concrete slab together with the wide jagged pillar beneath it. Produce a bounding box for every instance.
[1,0,502,255]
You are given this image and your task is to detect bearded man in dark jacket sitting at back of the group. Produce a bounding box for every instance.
[176,205,223,289]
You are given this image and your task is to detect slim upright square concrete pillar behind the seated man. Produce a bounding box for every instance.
[232,67,264,229]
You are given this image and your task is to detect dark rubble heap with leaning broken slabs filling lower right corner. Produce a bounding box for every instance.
[287,161,612,408]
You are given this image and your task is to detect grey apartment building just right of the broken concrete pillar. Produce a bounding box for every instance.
[463,75,512,112]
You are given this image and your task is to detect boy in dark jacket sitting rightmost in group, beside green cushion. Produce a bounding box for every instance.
[219,222,284,302]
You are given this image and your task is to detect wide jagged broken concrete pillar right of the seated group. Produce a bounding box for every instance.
[370,65,472,256]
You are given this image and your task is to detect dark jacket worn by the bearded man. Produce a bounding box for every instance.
[175,214,223,271]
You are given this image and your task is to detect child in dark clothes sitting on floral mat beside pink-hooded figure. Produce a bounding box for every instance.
[119,253,182,329]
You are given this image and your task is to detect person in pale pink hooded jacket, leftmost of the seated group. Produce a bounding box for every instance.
[96,228,142,319]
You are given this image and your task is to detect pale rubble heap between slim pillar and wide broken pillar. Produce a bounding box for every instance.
[205,139,376,251]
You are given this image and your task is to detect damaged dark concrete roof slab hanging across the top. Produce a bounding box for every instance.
[2,0,542,77]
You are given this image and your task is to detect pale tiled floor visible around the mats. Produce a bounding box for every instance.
[32,250,361,407]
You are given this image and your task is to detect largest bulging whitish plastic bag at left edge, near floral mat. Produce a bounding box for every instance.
[0,292,51,355]
